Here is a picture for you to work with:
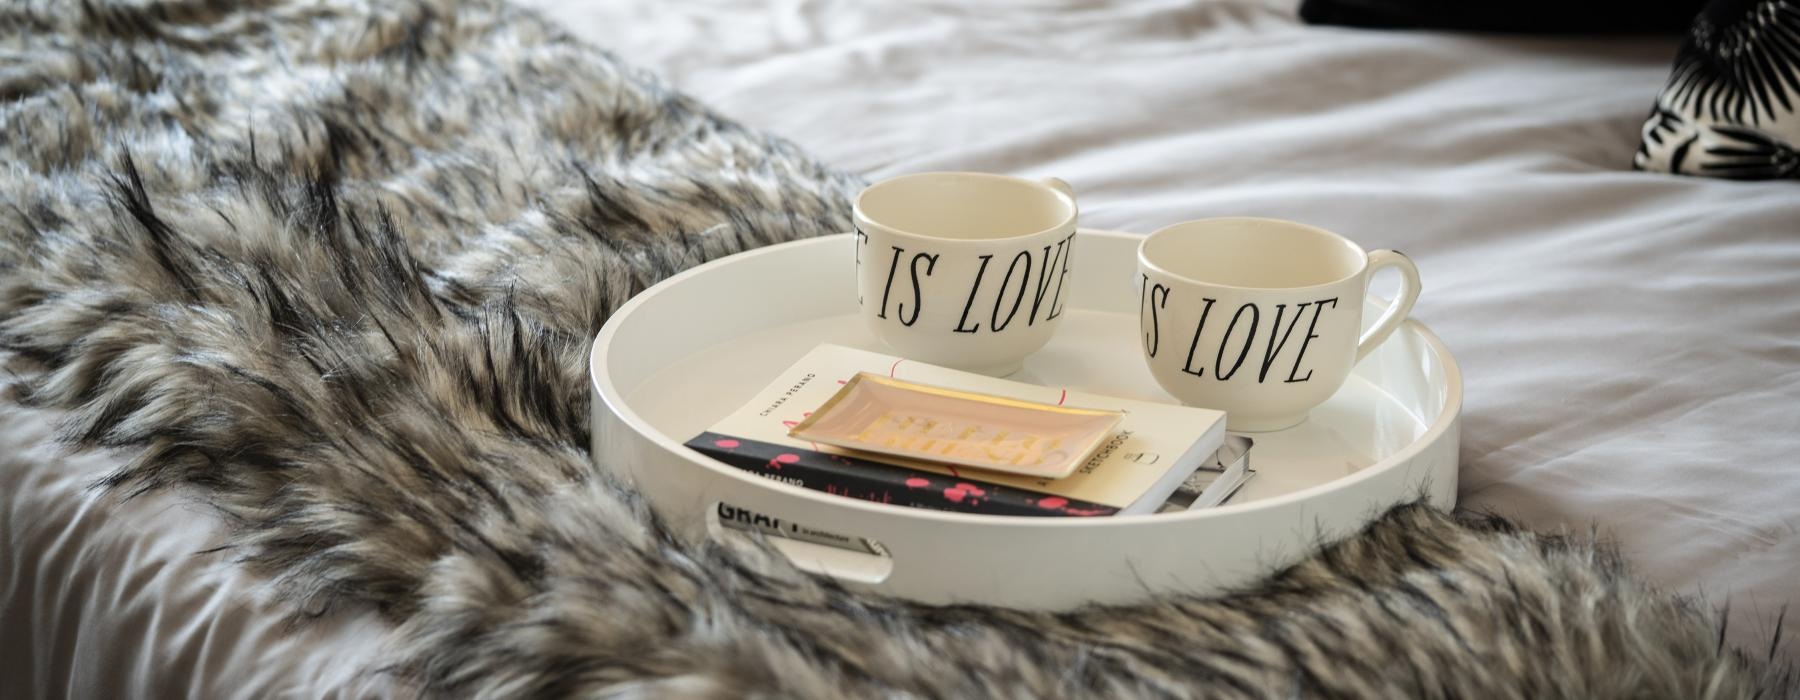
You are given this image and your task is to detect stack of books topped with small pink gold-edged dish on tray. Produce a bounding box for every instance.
[688,344,1255,518]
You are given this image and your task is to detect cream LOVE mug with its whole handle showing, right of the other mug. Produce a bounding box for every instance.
[1138,218,1418,432]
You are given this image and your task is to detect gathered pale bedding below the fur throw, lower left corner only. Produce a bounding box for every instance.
[0,401,392,698]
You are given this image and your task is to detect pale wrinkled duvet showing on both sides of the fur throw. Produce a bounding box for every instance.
[0,0,1800,696]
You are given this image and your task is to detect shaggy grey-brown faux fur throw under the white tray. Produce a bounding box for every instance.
[0,0,1795,698]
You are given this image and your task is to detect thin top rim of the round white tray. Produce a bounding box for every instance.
[589,229,1463,529]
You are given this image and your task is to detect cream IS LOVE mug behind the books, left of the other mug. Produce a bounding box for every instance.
[855,173,1076,376]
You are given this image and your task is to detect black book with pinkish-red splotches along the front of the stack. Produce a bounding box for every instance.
[688,432,1118,516]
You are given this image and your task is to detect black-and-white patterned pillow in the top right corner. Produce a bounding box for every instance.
[1634,0,1800,180]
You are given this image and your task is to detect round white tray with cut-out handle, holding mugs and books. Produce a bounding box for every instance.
[590,230,1462,608]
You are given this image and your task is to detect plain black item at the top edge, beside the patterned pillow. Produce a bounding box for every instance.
[1300,0,1705,34]
